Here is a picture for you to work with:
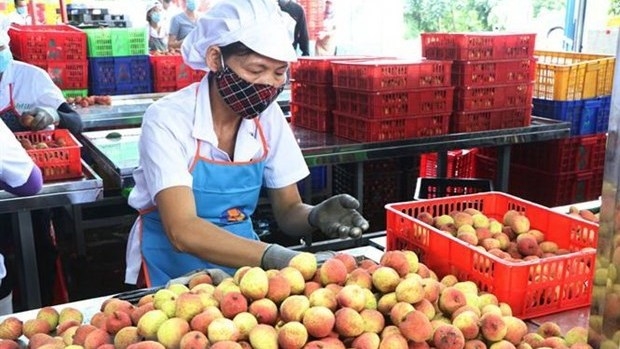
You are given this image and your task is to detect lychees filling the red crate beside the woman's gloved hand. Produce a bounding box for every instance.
[416,208,571,261]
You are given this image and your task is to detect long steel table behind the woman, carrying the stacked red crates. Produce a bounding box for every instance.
[82,117,570,194]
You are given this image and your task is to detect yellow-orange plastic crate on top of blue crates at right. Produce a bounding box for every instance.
[533,50,616,101]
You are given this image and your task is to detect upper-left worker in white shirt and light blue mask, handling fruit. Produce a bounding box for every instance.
[0,16,82,305]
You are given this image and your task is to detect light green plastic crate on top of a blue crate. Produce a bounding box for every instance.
[84,28,148,57]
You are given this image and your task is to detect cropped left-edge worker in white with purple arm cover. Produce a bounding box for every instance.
[0,117,43,315]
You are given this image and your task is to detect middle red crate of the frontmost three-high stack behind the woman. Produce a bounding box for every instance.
[335,87,454,119]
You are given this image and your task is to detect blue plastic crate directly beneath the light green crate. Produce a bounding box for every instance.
[89,56,153,95]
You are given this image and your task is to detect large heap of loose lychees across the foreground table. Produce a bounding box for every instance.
[0,250,589,349]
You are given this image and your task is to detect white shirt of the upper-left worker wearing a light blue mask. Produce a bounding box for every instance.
[0,61,65,114]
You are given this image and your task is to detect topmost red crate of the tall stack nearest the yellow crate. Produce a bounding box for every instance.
[420,32,536,61]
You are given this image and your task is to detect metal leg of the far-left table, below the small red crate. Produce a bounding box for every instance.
[11,210,41,309]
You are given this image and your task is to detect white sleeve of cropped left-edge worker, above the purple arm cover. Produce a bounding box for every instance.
[0,121,34,280]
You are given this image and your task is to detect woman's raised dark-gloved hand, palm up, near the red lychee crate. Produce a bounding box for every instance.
[308,194,369,239]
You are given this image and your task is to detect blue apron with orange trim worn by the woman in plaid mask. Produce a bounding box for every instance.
[140,118,267,286]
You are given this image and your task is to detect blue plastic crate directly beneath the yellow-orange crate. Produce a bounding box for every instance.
[532,96,611,136]
